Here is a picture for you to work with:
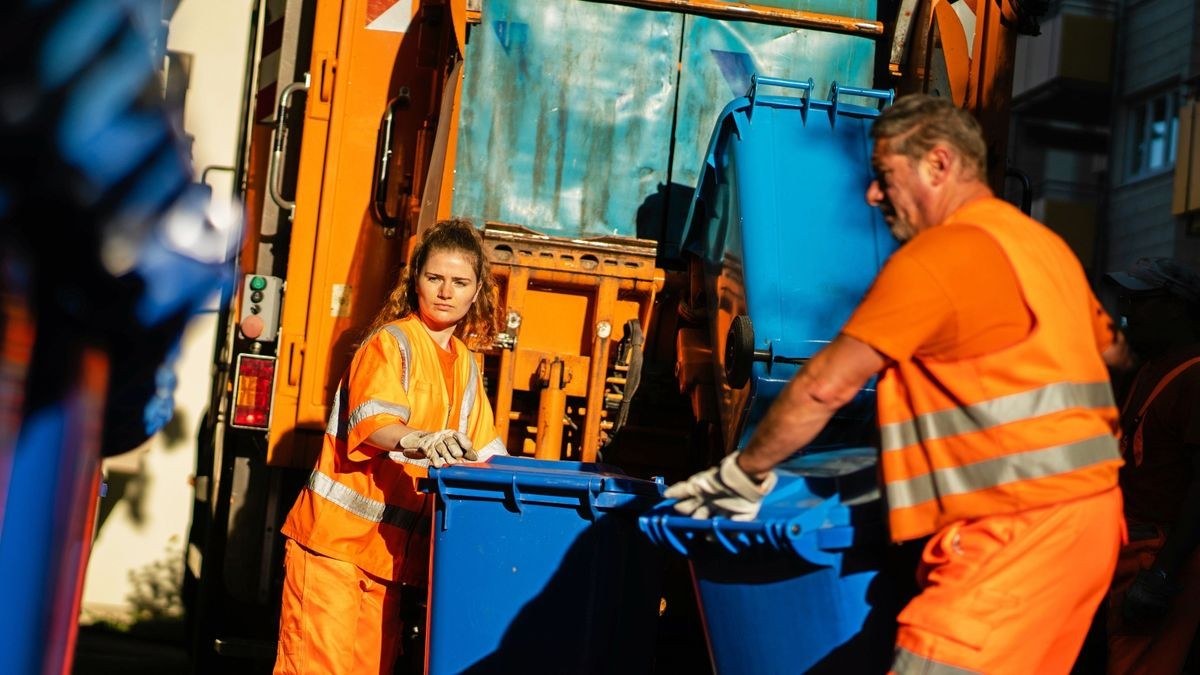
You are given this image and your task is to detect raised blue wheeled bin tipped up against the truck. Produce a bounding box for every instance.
[684,76,896,452]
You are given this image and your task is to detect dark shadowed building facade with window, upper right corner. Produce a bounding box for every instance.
[1007,0,1200,281]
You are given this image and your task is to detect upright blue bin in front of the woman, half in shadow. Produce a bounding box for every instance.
[426,456,662,674]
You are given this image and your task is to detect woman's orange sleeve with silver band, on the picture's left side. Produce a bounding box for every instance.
[346,330,412,461]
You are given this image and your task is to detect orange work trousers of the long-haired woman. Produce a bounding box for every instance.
[275,539,401,675]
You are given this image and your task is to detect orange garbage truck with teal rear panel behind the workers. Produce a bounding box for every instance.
[184,0,1036,673]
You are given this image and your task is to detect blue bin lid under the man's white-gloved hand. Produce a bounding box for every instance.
[638,447,886,565]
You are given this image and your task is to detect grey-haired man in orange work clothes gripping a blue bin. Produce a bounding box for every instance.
[666,95,1124,675]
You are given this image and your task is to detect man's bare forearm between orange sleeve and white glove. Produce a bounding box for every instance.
[738,335,887,480]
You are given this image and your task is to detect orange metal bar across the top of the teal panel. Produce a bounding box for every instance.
[587,0,883,38]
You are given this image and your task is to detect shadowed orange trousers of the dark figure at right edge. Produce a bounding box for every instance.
[1108,525,1200,675]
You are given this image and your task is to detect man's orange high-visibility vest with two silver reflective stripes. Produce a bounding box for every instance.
[877,198,1121,542]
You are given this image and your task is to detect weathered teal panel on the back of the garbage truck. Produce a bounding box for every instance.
[451,0,875,247]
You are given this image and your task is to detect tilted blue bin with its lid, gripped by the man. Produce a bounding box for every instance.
[641,448,904,675]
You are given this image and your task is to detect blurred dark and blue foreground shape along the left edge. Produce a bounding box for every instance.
[0,0,239,674]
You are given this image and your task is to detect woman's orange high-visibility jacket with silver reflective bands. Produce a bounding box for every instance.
[281,317,506,585]
